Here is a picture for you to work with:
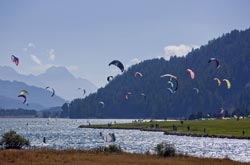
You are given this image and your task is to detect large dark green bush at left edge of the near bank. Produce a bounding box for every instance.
[0,131,30,149]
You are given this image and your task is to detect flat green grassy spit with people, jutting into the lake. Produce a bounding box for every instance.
[79,118,250,138]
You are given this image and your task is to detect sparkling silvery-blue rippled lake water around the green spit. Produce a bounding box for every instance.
[0,118,250,162]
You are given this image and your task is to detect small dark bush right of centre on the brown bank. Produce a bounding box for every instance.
[155,142,175,157]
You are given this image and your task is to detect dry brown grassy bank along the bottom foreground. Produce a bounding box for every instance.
[0,149,246,165]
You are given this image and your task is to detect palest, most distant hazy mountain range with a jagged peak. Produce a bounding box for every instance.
[0,66,97,100]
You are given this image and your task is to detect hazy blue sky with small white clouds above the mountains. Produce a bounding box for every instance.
[0,0,250,87]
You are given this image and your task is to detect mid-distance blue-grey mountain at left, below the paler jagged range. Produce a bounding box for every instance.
[0,80,65,110]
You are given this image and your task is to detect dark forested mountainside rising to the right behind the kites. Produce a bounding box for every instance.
[66,29,250,118]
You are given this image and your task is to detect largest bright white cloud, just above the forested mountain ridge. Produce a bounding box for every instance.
[164,44,199,60]
